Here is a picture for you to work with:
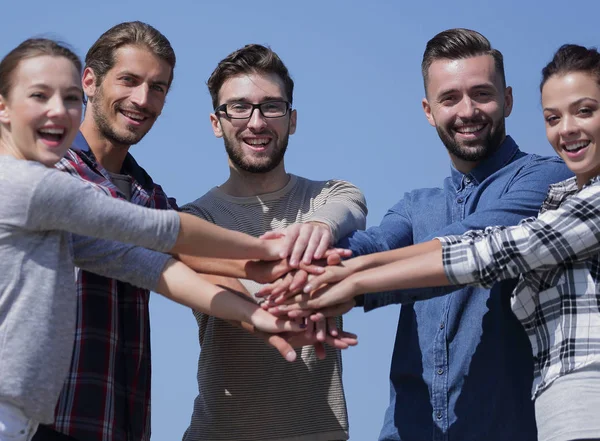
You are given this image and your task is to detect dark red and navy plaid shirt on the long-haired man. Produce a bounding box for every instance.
[49,133,177,441]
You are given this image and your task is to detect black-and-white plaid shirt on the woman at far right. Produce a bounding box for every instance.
[438,177,600,398]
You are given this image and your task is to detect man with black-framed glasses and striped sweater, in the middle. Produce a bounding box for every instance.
[183,45,367,441]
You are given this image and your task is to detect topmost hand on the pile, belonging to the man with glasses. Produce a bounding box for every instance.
[261,222,333,268]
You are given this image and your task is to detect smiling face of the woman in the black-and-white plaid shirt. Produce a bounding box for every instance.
[542,72,600,188]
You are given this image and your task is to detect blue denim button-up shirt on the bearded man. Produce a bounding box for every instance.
[341,137,572,441]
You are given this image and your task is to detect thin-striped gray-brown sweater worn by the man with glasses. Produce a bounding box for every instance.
[182,175,366,441]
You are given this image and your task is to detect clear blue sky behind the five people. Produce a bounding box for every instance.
[5,0,600,441]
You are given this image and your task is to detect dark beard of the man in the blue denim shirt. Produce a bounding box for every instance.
[436,118,506,162]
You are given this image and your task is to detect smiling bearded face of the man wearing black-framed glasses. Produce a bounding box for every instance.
[210,73,296,173]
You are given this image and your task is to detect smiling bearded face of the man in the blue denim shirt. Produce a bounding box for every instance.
[423,55,512,173]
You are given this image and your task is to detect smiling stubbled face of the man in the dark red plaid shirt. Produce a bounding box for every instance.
[83,46,172,147]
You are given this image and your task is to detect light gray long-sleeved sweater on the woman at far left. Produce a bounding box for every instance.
[0,156,179,423]
